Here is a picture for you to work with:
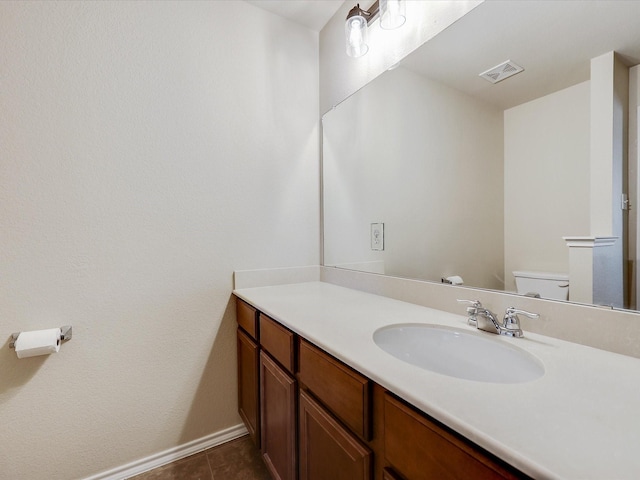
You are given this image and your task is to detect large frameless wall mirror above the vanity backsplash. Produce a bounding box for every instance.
[322,0,640,308]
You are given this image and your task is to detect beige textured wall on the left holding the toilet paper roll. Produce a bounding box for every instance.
[0,1,319,480]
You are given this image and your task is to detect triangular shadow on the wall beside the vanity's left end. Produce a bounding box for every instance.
[179,296,242,444]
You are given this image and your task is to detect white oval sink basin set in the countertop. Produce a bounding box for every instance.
[373,324,544,383]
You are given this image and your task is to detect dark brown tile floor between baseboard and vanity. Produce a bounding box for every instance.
[129,436,271,480]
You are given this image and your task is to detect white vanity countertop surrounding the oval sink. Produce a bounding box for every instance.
[234,282,640,480]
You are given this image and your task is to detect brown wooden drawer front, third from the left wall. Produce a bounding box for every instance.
[298,339,371,440]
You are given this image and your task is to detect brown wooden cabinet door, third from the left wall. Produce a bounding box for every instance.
[299,390,372,480]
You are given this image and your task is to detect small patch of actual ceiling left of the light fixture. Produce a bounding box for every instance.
[245,0,344,32]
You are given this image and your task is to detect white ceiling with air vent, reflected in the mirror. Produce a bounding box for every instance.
[402,0,640,109]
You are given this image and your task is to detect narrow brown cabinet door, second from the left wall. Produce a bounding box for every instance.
[260,351,297,480]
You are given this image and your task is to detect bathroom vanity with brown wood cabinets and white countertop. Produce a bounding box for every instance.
[234,282,640,480]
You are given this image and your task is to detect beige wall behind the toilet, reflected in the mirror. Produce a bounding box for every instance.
[504,81,590,291]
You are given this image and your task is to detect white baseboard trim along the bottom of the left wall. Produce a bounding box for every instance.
[84,424,248,480]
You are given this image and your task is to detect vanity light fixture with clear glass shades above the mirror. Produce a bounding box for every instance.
[344,0,407,58]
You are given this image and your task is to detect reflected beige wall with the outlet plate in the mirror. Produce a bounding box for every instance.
[323,67,504,289]
